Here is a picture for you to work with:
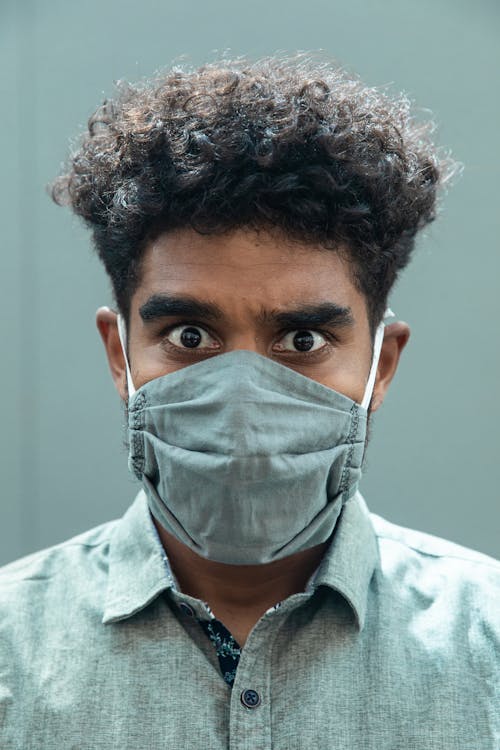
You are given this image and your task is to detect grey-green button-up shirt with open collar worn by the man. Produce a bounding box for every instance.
[0,492,500,750]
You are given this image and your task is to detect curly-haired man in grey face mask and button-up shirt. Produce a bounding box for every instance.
[0,56,500,750]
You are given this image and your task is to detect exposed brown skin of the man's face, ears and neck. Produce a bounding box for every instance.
[96,229,410,647]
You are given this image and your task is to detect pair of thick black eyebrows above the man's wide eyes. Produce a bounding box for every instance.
[139,294,354,329]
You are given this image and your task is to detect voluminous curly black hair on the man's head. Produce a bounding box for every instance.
[50,53,454,332]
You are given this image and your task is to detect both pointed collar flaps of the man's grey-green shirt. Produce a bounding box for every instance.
[102,490,378,629]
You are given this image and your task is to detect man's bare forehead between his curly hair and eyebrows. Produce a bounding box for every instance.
[134,229,364,307]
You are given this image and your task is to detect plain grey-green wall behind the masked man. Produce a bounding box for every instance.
[0,0,500,563]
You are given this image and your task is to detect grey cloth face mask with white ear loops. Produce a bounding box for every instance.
[119,312,390,565]
